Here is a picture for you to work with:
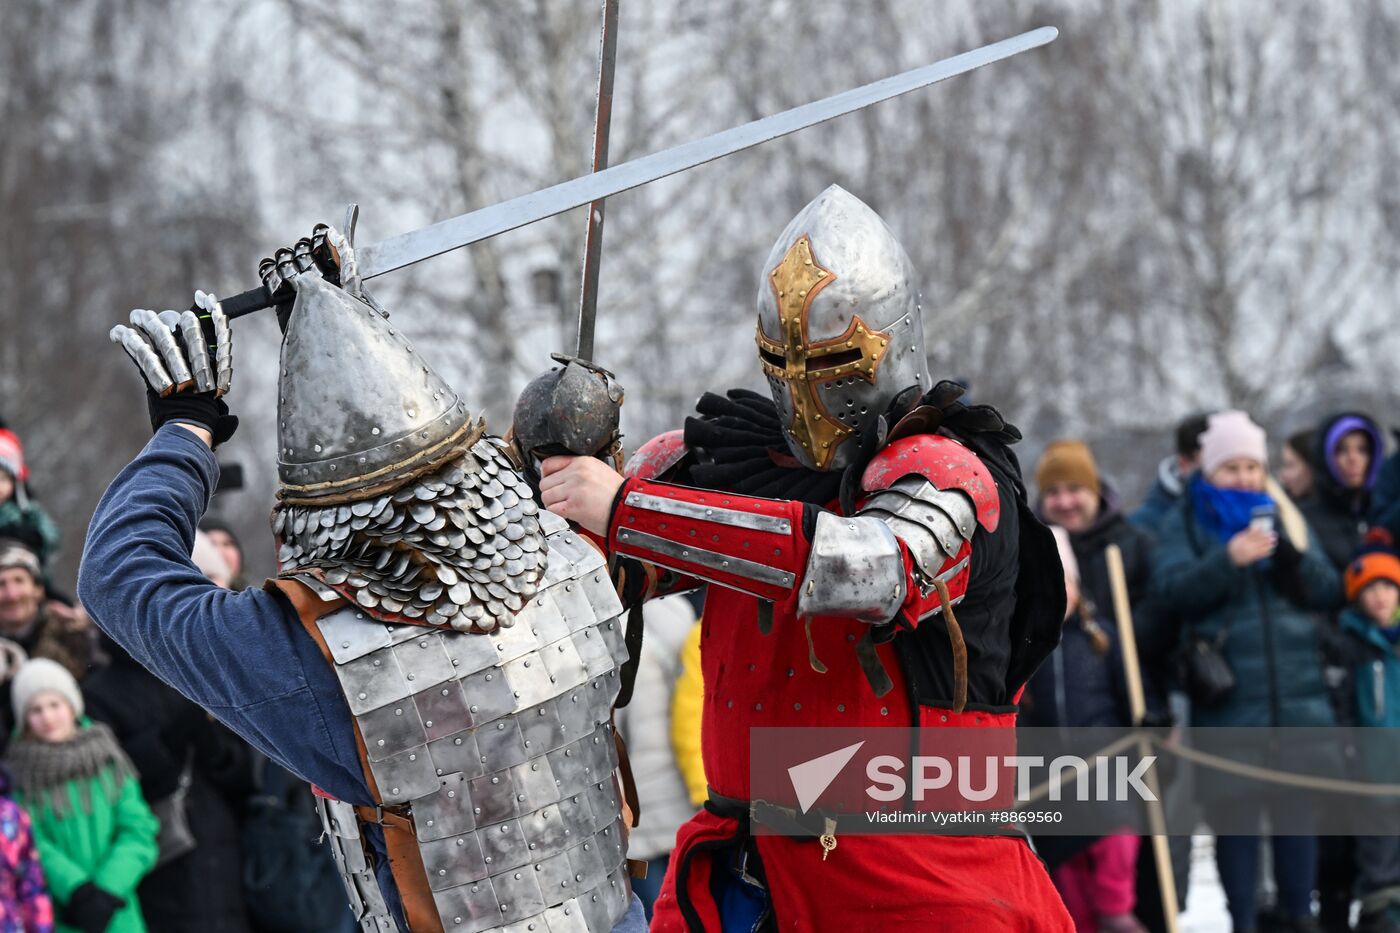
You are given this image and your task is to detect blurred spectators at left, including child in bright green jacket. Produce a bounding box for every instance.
[0,426,358,933]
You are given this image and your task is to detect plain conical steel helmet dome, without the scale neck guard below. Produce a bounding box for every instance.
[277,272,482,502]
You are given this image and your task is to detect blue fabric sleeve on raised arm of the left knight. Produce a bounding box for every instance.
[78,424,407,930]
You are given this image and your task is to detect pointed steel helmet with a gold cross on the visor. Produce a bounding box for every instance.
[757,185,930,471]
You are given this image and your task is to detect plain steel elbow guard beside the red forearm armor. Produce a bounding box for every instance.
[797,511,904,623]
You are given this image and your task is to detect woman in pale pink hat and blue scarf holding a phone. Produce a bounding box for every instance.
[1154,410,1341,930]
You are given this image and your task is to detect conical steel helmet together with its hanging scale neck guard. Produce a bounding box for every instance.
[272,261,547,632]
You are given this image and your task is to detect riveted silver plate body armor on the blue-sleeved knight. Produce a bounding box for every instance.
[316,511,629,933]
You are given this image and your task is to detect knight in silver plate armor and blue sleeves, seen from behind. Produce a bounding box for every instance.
[80,227,644,933]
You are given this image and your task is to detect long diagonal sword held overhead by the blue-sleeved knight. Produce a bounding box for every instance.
[223,27,1058,318]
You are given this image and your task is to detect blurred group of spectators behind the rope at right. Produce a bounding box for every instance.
[1021,410,1400,933]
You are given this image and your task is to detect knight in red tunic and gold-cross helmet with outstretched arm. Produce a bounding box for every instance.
[542,186,1074,932]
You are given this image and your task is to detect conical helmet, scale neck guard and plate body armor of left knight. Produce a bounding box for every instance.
[273,238,630,933]
